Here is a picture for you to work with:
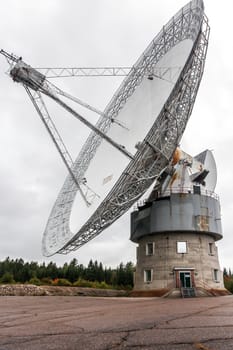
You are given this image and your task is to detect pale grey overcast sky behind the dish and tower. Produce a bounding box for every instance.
[0,0,233,267]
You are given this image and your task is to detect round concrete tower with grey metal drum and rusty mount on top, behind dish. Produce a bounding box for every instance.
[131,150,227,295]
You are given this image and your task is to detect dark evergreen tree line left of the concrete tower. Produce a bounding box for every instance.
[0,257,134,288]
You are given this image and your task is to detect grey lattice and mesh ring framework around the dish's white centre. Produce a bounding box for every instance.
[39,0,209,255]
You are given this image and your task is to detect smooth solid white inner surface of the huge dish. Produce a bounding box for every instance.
[70,40,192,231]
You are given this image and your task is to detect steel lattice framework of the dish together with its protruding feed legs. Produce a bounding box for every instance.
[1,0,209,256]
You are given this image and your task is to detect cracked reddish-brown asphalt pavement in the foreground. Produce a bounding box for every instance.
[0,296,233,350]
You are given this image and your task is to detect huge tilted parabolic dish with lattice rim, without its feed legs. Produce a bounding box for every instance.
[42,0,209,256]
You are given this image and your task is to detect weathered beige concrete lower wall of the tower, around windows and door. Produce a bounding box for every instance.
[134,232,224,290]
